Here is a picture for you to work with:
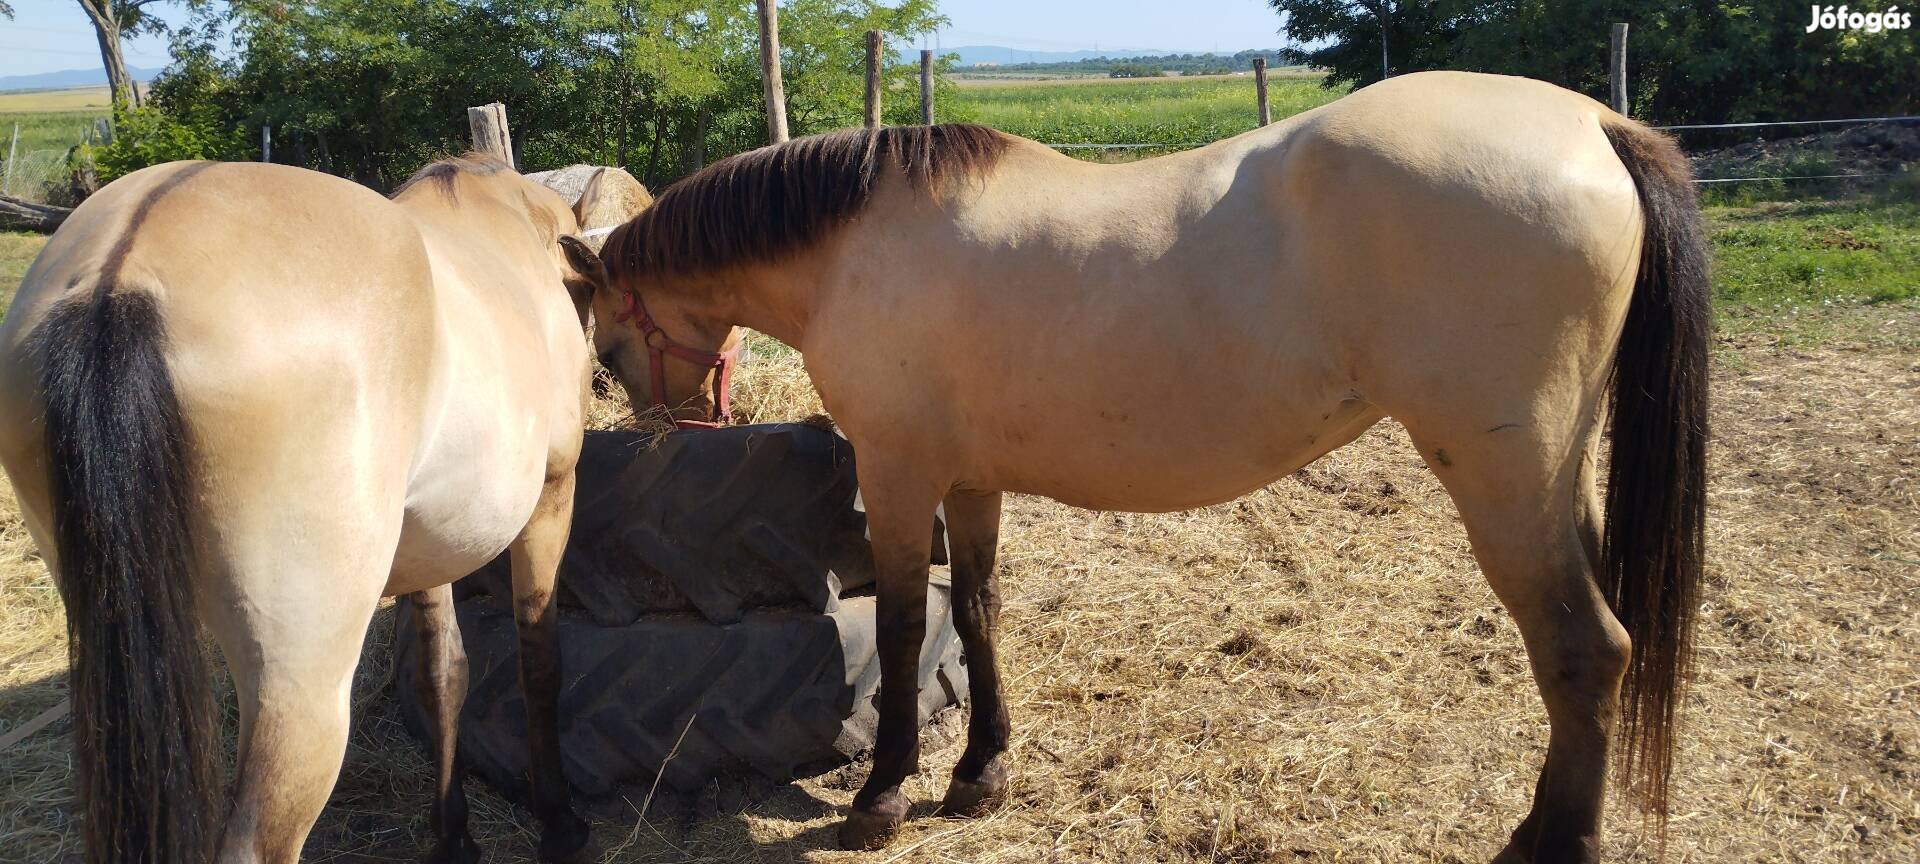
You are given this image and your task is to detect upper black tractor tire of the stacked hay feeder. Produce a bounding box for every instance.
[455,422,947,626]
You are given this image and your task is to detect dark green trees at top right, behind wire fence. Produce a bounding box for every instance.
[1269,0,1920,123]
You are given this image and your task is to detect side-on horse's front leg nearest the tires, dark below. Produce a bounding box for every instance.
[839,466,945,849]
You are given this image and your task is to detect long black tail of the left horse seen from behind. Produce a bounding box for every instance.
[35,284,221,864]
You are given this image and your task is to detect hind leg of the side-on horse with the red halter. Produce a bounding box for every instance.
[1407,419,1630,864]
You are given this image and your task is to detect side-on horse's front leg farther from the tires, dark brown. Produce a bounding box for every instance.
[941,492,1012,816]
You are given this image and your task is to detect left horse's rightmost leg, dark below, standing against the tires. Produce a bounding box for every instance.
[509,468,591,862]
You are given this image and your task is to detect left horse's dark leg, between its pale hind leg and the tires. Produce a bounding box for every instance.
[411,586,480,864]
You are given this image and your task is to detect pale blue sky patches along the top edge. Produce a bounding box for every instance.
[0,0,1283,75]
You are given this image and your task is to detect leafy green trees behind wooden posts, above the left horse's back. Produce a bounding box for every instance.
[113,0,945,188]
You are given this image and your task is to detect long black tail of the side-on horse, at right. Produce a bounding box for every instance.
[1599,121,1713,824]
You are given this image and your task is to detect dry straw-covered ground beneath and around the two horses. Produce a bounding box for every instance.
[0,307,1920,864]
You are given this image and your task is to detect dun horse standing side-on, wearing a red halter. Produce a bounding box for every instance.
[593,73,1709,864]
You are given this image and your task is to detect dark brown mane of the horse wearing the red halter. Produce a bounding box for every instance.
[603,123,1014,282]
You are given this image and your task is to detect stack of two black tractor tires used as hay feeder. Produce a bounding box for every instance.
[394,424,966,799]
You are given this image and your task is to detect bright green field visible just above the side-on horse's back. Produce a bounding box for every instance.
[943,77,1344,161]
